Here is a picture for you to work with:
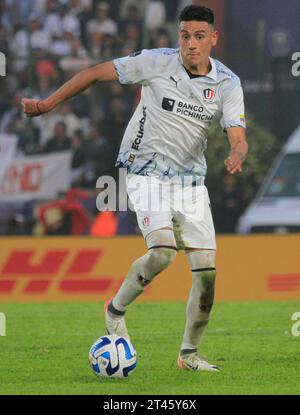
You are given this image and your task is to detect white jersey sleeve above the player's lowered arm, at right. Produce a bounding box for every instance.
[220,80,246,131]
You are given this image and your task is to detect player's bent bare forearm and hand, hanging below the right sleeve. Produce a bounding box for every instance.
[224,127,248,174]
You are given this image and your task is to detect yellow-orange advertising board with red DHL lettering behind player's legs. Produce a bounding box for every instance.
[0,235,300,303]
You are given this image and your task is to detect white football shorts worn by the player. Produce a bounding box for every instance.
[126,173,216,249]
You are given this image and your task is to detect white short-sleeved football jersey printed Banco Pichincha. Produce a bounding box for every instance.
[114,48,245,180]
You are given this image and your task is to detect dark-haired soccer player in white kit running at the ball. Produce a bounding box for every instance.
[22,5,248,371]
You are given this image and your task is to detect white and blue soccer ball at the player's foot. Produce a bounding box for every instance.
[89,334,137,379]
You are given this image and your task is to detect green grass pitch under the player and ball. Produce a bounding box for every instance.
[0,301,300,395]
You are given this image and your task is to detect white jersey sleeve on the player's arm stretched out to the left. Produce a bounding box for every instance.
[113,49,156,84]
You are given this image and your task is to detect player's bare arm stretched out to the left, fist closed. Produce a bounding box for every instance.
[21,61,118,117]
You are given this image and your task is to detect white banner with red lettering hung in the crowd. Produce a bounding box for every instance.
[0,151,71,202]
